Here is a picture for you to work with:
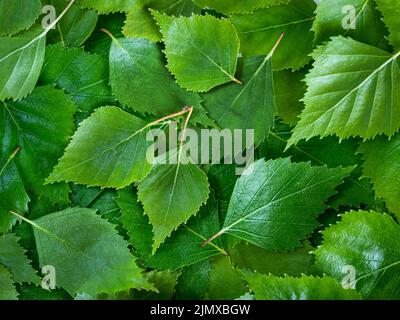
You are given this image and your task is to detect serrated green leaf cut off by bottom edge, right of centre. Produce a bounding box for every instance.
[244,273,360,300]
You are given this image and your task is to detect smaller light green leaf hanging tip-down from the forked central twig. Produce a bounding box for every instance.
[138,155,209,253]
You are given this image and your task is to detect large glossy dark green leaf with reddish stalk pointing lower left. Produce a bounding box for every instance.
[208,158,352,250]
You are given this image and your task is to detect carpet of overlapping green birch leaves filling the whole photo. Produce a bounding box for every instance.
[0,0,400,299]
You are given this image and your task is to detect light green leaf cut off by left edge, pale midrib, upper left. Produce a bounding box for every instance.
[0,26,46,101]
